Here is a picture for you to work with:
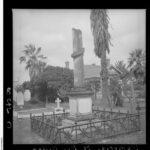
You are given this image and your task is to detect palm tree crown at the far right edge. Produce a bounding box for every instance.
[128,49,145,80]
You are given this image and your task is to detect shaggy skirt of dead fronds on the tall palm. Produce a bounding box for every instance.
[90,9,111,58]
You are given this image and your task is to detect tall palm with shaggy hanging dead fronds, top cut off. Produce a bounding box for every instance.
[90,9,111,104]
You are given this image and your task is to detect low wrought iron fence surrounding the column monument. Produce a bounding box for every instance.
[30,110,140,144]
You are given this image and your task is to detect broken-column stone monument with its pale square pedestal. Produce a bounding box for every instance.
[68,28,93,119]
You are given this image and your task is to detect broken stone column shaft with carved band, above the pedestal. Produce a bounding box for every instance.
[71,28,84,87]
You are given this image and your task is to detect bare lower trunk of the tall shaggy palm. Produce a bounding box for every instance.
[101,50,110,106]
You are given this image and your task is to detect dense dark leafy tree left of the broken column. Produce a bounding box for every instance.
[34,66,73,102]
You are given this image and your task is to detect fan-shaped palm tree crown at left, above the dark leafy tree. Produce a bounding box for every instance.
[19,44,46,81]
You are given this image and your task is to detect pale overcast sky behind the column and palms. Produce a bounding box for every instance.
[13,9,146,82]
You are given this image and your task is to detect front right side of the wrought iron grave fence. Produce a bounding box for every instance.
[55,114,140,144]
